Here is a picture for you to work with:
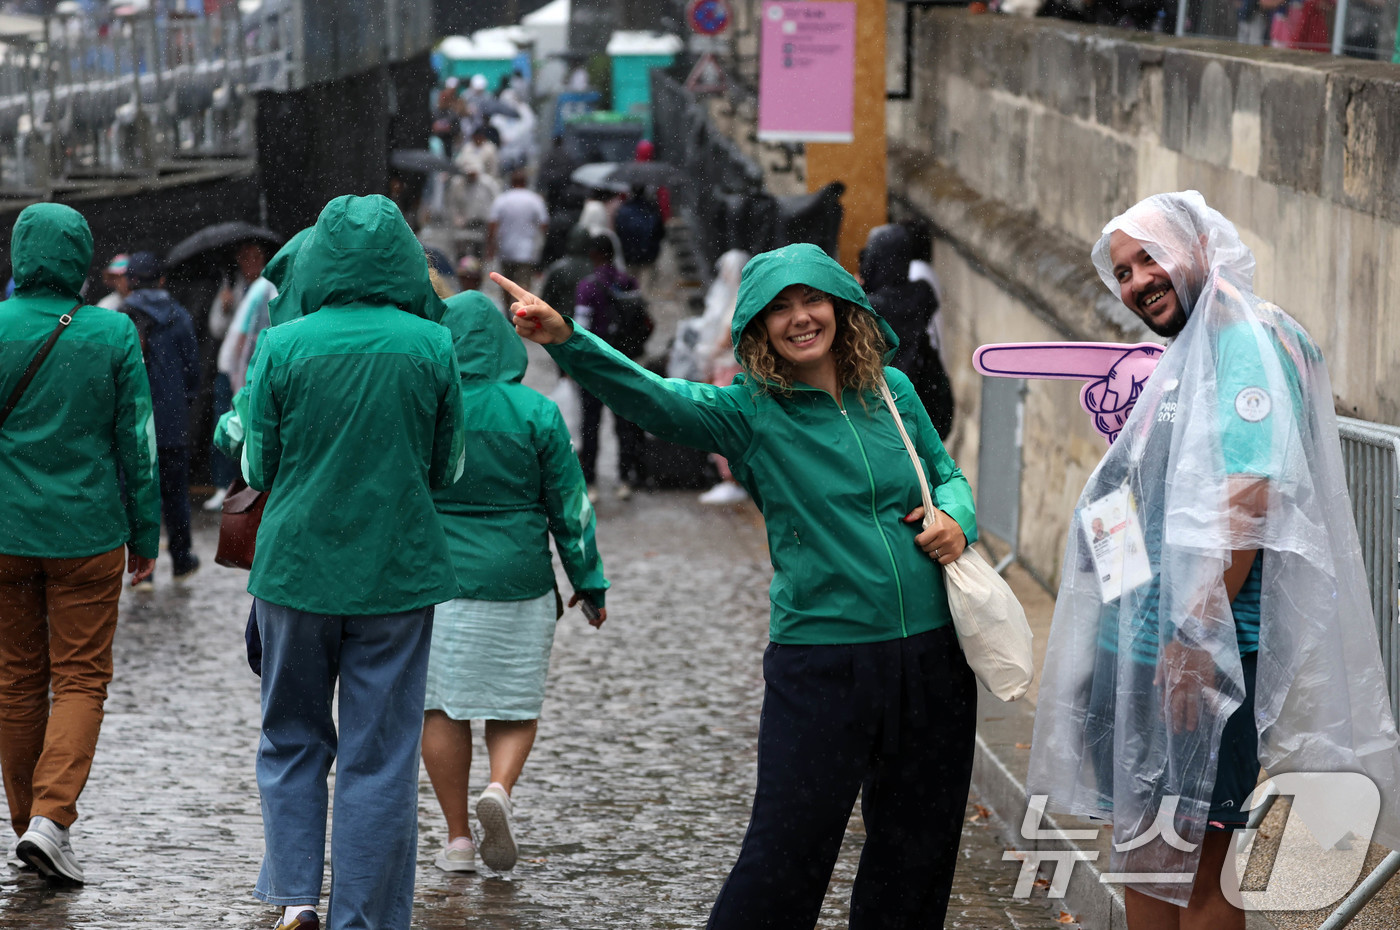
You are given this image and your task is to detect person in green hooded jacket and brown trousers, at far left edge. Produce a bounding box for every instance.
[0,203,161,884]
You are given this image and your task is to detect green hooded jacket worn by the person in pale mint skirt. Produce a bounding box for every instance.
[433,291,608,606]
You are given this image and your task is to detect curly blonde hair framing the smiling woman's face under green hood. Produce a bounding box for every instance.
[738,289,889,403]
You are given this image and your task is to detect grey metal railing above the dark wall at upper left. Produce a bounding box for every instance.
[0,4,295,196]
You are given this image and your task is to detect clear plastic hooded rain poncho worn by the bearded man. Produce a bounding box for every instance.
[1028,190,1400,905]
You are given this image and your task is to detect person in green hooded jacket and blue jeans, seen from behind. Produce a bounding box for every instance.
[242,196,463,930]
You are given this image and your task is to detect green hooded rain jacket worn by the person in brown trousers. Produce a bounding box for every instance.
[0,203,161,559]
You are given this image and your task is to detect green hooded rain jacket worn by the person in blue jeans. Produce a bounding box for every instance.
[242,196,463,616]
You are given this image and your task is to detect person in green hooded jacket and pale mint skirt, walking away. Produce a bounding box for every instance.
[423,291,608,871]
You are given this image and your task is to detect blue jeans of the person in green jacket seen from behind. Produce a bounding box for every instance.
[253,598,433,930]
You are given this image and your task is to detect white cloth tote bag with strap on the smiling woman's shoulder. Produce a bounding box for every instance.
[879,378,1035,700]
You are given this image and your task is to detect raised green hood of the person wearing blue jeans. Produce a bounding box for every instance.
[274,195,447,322]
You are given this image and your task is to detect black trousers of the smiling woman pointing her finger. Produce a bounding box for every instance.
[708,626,977,930]
